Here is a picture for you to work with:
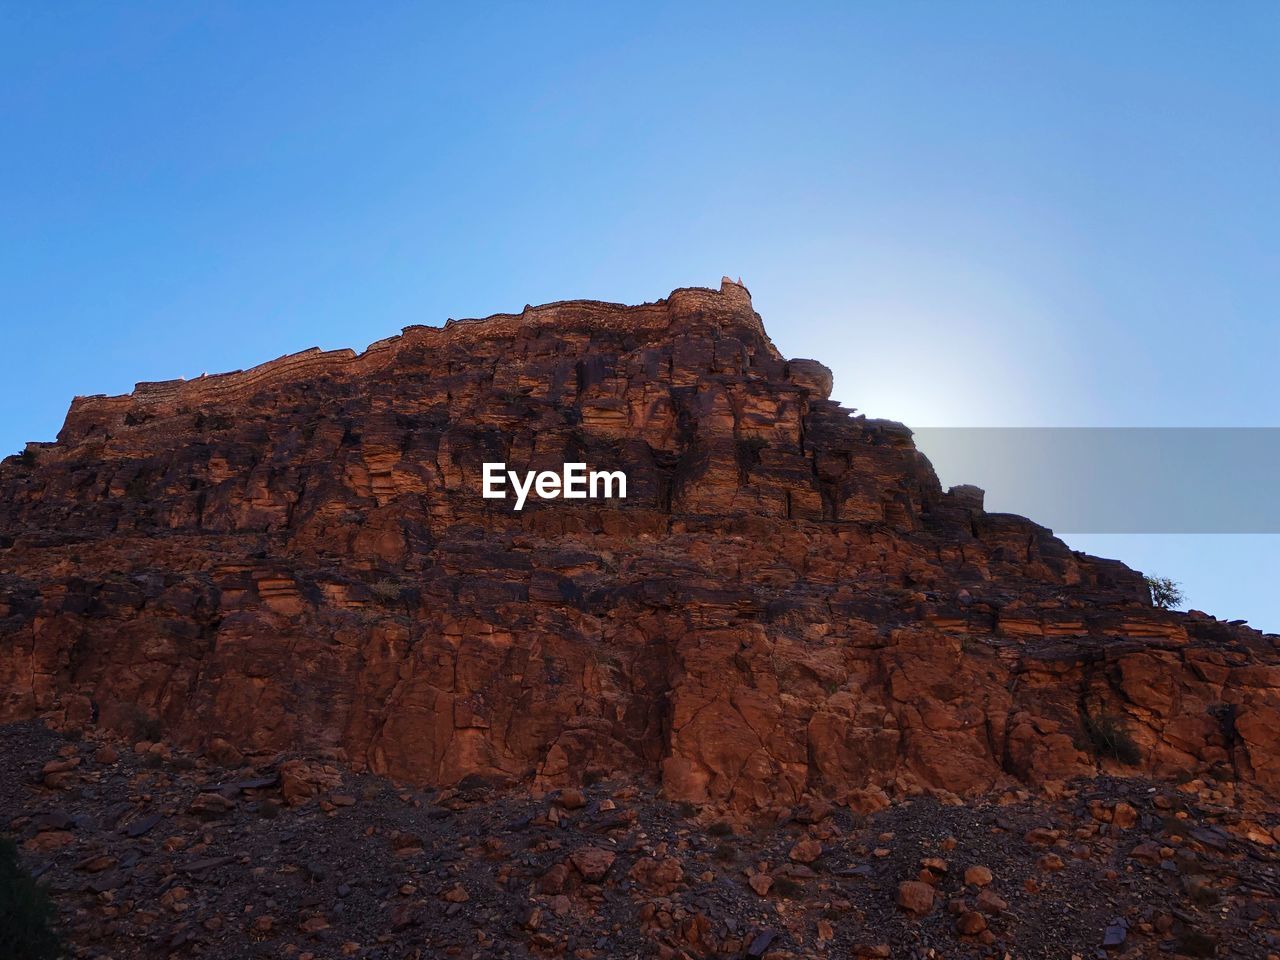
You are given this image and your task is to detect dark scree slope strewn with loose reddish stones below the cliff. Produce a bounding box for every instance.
[0,722,1280,960]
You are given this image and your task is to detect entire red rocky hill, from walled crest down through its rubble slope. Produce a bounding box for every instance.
[0,279,1280,960]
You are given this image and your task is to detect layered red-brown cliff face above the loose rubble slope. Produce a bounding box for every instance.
[0,283,1280,812]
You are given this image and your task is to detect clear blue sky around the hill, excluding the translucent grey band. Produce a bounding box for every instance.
[0,0,1280,630]
